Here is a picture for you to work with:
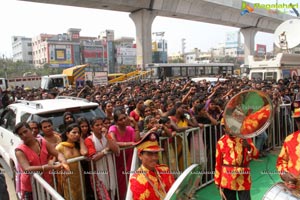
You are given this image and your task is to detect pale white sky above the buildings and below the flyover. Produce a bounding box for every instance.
[0,0,300,58]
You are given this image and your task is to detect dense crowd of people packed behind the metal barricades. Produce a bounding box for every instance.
[0,75,300,199]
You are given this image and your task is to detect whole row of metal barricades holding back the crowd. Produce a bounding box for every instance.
[32,105,294,200]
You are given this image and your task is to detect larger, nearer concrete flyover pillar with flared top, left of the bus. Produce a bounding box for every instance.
[129,9,157,70]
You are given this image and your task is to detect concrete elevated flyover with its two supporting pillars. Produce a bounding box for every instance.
[23,0,294,65]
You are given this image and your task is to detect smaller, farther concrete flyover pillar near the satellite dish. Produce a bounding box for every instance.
[240,28,257,65]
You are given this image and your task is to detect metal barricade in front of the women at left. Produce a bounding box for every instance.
[31,147,133,200]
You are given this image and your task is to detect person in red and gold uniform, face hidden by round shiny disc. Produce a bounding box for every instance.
[215,134,258,200]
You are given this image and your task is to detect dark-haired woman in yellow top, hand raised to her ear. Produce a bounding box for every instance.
[56,123,87,200]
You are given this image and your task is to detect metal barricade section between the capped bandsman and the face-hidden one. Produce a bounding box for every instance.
[159,124,222,187]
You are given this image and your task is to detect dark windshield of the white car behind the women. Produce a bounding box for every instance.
[32,107,105,132]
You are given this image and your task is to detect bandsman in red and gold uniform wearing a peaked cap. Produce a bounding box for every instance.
[130,133,174,200]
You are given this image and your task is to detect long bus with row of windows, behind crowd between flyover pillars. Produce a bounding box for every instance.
[146,63,234,79]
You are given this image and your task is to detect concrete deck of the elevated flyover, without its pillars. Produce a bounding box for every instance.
[23,0,292,33]
